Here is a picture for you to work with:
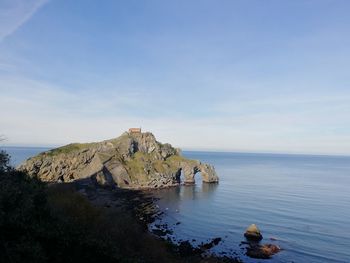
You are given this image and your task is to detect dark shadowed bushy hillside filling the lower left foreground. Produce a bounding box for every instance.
[0,153,175,263]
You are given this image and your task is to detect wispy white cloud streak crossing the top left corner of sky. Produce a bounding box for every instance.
[0,0,48,42]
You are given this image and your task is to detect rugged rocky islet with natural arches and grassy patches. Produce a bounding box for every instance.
[17,132,219,189]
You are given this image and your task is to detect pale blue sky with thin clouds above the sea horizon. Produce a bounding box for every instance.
[0,0,350,155]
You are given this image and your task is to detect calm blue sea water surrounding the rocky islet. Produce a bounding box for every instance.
[5,148,350,263]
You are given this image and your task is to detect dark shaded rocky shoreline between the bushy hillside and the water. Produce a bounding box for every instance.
[69,180,242,263]
